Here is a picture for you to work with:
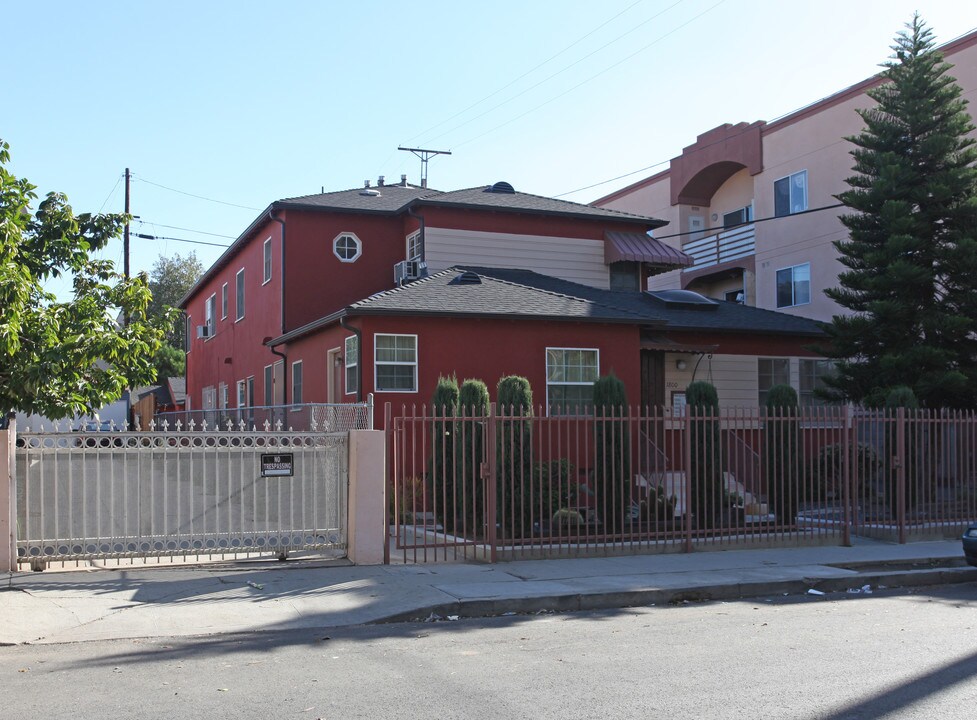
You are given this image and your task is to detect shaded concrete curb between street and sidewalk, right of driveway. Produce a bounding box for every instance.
[378,563,977,624]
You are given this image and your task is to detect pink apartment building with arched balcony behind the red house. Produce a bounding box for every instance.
[593,32,977,404]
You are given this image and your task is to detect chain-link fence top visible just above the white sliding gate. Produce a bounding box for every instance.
[154,395,373,432]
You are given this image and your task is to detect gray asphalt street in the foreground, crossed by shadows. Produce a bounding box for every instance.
[0,583,977,720]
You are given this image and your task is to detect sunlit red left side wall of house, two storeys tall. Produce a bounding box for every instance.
[187,217,281,410]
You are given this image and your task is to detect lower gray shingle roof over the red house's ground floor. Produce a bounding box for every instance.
[347,267,821,337]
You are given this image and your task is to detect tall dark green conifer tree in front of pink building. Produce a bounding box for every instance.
[822,16,977,407]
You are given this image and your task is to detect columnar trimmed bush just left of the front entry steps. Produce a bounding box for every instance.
[685,380,726,527]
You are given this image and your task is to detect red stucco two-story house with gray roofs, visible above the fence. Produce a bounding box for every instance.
[182,180,819,422]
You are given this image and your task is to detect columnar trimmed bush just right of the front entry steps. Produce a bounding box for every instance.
[763,385,804,525]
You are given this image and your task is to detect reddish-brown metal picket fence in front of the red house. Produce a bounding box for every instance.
[387,407,977,561]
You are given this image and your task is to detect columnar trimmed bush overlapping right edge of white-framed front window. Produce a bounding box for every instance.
[594,372,631,531]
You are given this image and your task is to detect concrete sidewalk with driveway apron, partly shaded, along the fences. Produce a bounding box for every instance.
[0,540,977,644]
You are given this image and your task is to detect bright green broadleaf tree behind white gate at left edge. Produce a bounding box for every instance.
[0,141,170,419]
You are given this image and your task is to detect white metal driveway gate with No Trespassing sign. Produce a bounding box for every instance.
[16,422,348,567]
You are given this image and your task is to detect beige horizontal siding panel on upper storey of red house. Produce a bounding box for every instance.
[424,227,610,289]
